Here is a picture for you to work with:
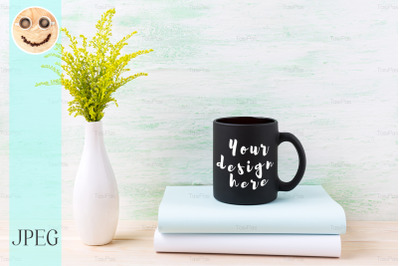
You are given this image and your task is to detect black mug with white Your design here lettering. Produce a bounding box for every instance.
[213,117,306,204]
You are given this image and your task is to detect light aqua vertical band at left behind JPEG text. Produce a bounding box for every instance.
[9,0,61,266]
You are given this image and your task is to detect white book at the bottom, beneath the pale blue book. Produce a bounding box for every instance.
[154,228,341,257]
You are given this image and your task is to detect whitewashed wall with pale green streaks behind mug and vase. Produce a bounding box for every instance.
[0,0,398,220]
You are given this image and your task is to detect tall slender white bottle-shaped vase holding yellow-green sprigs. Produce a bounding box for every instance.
[73,121,119,245]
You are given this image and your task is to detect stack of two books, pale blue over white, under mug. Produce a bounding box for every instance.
[154,185,346,257]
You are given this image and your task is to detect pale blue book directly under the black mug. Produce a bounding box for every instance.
[158,185,346,234]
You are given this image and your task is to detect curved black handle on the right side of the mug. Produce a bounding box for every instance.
[278,133,306,191]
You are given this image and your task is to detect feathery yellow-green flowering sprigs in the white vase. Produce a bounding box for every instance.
[36,9,153,122]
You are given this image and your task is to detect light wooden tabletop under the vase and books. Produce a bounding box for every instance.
[57,220,398,266]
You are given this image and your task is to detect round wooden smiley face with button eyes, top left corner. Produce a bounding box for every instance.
[12,7,58,54]
